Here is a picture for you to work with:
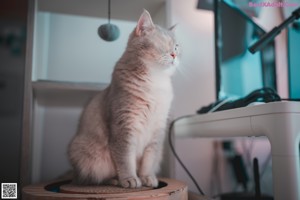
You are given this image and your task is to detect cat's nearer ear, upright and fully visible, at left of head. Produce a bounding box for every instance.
[135,9,154,36]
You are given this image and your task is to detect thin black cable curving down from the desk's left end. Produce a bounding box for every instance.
[168,115,205,196]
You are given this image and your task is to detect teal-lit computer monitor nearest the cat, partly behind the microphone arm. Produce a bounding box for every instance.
[215,0,276,99]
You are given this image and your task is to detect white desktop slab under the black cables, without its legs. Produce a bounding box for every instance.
[173,101,300,137]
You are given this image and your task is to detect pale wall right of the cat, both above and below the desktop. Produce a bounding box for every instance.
[169,0,215,195]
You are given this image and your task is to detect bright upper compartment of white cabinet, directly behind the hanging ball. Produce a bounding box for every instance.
[34,12,136,83]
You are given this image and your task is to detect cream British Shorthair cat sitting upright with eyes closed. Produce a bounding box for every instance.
[68,10,180,188]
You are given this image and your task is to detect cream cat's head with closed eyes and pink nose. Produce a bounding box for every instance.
[128,10,180,72]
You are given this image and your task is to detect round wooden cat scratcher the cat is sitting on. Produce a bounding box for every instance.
[22,178,188,200]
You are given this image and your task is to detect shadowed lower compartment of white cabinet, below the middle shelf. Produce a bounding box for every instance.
[31,90,95,183]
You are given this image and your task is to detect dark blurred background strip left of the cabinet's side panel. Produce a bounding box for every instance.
[0,0,28,187]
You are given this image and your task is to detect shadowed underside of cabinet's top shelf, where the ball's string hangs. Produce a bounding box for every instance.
[38,0,166,21]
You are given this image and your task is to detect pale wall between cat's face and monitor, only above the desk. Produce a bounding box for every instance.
[170,0,215,117]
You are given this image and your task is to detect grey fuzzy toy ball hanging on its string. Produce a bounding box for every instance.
[98,0,120,42]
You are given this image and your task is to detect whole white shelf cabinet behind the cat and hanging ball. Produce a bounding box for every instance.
[22,0,167,183]
